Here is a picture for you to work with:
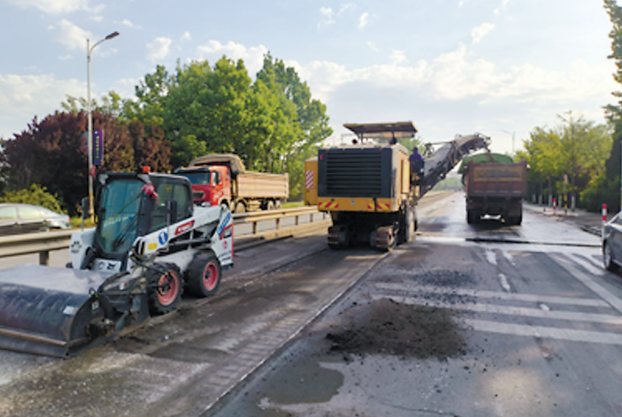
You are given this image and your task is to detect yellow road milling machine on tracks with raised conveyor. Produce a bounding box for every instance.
[305,122,490,251]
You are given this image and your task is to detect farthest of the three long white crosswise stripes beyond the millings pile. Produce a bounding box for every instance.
[375,282,610,307]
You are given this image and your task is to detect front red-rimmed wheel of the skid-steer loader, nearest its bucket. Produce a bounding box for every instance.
[147,263,183,315]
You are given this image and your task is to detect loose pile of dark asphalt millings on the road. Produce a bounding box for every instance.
[326,298,465,360]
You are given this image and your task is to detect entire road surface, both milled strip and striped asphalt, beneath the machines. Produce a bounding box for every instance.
[0,194,622,417]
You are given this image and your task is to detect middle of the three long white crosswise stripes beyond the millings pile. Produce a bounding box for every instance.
[372,294,622,326]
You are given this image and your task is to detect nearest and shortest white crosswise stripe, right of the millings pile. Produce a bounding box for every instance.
[464,319,622,345]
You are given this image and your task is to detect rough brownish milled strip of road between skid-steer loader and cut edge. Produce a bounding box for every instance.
[0,195,454,416]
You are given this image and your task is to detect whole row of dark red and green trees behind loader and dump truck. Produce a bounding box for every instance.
[0,51,332,210]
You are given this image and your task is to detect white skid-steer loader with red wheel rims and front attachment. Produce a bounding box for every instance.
[0,173,233,357]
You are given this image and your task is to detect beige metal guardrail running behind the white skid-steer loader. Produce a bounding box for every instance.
[0,207,326,265]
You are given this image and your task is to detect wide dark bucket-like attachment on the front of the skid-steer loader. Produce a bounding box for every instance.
[0,265,149,357]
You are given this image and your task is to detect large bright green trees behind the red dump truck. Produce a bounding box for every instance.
[121,55,332,198]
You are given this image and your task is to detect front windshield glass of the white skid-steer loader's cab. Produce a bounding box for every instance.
[95,179,145,254]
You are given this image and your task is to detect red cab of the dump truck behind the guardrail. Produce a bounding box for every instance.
[175,165,232,207]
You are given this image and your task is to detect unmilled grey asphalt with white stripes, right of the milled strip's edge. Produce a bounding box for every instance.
[210,196,622,417]
